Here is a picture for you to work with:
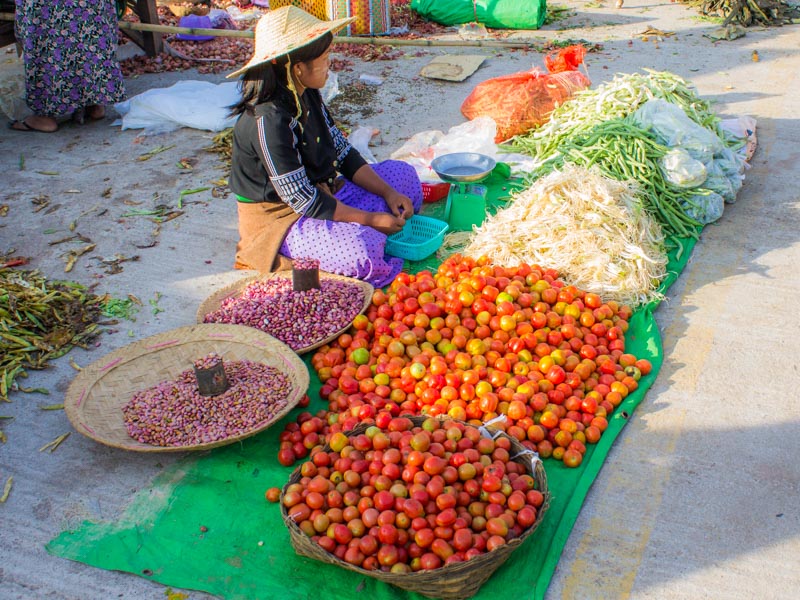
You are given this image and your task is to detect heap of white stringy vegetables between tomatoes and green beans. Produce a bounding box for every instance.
[463,163,667,307]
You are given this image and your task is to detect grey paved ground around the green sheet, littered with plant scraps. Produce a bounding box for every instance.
[0,0,800,599]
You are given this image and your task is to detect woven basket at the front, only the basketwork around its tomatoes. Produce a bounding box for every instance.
[281,417,550,600]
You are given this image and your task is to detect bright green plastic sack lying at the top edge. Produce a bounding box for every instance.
[411,0,546,29]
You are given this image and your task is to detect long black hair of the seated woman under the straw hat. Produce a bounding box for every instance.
[230,32,333,117]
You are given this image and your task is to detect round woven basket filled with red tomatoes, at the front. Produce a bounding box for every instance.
[280,416,550,600]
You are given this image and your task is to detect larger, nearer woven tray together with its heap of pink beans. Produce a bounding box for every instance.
[64,324,308,452]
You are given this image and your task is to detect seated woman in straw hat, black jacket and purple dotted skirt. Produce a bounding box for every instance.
[229,6,422,287]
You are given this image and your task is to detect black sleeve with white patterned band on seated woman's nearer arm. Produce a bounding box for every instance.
[256,115,336,219]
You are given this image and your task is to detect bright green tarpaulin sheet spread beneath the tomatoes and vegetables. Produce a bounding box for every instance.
[47,176,695,600]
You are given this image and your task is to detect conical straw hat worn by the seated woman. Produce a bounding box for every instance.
[227,6,356,78]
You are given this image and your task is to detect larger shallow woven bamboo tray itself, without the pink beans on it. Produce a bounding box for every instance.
[64,325,309,452]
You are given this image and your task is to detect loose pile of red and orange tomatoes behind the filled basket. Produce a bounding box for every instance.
[278,255,652,467]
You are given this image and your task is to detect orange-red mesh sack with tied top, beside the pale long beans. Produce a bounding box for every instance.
[461,46,592,144]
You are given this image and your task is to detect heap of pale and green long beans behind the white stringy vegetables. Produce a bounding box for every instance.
[513,71,745,237]
